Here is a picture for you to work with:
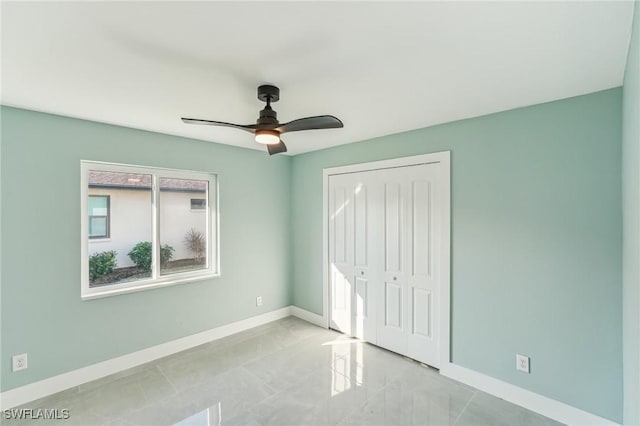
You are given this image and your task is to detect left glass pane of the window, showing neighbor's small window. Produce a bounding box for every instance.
[87,170,152,287]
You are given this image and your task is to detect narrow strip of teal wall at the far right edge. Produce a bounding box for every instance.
[622,1,640,425]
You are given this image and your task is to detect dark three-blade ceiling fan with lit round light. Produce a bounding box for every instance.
[182,85,344,155]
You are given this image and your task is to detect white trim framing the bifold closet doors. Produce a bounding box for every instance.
[322,151,451,366]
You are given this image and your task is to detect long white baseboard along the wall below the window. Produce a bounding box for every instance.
[0,306,292,410]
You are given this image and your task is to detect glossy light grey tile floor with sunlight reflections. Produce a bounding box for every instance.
[7,317,558,426]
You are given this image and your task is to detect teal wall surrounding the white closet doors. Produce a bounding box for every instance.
[292,88,622,421]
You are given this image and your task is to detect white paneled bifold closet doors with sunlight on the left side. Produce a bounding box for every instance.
[329,163,442,367]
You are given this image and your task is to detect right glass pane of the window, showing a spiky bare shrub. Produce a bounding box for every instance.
[159,178,209,275]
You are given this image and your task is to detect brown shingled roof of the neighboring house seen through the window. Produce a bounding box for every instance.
[89,170,207,192]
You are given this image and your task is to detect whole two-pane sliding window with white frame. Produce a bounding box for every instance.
[81,161,218,299]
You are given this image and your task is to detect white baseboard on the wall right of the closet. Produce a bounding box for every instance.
[440,363,618,426]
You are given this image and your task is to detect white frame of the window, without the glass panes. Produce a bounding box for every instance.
[80,160,220,300]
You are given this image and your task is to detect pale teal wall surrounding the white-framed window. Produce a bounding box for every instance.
[0,107,291,391]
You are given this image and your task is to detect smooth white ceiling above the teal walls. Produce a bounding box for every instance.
[1,1,633,154]
